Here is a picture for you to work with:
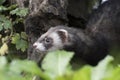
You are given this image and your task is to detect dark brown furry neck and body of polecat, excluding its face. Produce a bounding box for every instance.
[42,0,120,65]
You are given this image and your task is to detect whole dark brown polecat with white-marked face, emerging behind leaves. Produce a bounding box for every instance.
[33,0,120,65]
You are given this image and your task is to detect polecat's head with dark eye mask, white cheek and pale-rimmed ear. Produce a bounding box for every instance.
[33,27,68,52]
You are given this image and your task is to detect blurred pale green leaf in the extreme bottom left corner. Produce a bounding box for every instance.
[0,56,29,80]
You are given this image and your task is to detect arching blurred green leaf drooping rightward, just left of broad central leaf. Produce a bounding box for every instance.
[10,60,49,80]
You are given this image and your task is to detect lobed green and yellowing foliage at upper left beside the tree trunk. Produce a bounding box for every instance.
[0,0,28,55]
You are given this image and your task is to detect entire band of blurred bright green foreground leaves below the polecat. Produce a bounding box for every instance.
[0,51,120,80]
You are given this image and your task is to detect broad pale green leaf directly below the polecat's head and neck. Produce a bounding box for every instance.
[42,51,73,78]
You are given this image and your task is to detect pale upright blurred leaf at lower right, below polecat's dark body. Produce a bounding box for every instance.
[91,56,113,80]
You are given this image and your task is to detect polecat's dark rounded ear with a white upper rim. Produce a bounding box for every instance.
[57,29,68,43]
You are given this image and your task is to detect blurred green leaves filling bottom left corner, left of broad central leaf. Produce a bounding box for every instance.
[0,56,48,80]
